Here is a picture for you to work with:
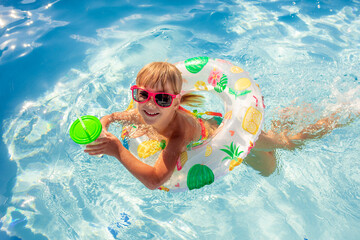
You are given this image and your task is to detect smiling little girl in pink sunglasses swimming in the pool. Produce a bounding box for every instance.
[85,62,348,189]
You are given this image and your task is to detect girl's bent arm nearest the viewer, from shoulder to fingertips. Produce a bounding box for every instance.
[85,133,183,190]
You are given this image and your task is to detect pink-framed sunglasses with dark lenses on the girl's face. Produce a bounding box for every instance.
[130,85,180,108]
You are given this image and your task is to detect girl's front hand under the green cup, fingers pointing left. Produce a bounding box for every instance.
[84,131,121,157]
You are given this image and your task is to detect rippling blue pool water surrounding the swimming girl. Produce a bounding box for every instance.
[0,0,360,240]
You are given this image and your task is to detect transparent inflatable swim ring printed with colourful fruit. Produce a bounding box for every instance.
[121,57,265,191]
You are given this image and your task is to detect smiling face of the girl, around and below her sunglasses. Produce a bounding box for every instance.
[137,83,180,129]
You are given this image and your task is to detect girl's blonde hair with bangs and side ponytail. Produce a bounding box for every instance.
[136,62,204,107]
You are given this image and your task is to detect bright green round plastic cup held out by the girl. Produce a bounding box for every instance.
[70,115,102,145]
